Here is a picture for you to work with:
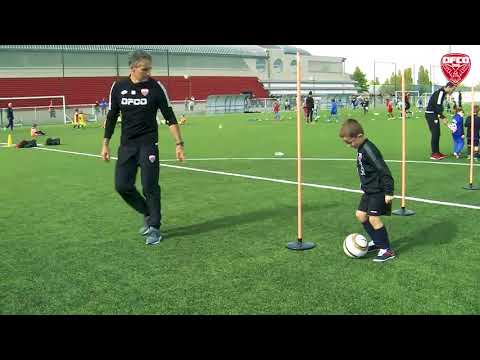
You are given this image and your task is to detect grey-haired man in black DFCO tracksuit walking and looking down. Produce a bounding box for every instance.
[102,50,184,245]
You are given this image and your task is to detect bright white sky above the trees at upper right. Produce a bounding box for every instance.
[293,45,480,86]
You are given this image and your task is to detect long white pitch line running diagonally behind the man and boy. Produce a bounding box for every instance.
[33,148,480,210]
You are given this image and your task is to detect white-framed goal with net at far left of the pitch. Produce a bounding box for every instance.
[0,95,68,125]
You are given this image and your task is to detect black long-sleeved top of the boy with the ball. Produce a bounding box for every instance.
[357,139,394,196]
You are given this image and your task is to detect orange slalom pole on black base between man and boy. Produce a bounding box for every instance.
[287,52,315,250]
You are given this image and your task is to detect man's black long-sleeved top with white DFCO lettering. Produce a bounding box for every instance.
[104,77,177,144]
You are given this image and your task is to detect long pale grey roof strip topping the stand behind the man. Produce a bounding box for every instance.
[0,45,267,58]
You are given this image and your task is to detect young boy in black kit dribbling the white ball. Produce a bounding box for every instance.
[339,119,395,262]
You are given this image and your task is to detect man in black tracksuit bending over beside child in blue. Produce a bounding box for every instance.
[425,82,456,160]
